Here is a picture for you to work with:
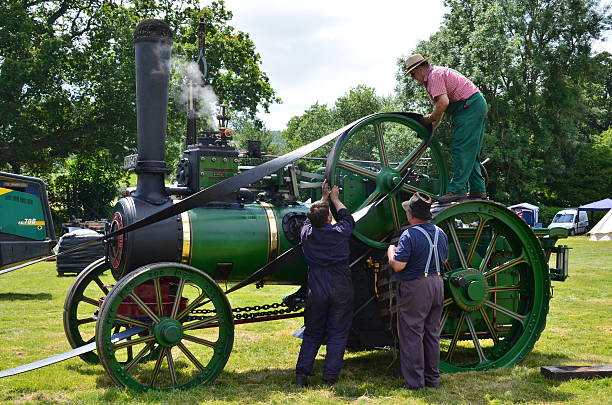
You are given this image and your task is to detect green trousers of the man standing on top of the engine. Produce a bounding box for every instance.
[446,92,487,194]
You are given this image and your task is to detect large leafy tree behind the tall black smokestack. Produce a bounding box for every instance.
[0,0,278,174]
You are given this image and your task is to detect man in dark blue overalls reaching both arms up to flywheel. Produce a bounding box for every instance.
[295,183,355,387]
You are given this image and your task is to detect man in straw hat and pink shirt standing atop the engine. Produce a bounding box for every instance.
[404,53,487,204]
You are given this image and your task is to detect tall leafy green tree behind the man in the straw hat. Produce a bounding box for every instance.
[397,0,610,203]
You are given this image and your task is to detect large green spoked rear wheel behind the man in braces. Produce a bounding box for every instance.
[433,202,550,373]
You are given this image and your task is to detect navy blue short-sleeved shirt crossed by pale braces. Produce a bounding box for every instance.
[393,223,448,280]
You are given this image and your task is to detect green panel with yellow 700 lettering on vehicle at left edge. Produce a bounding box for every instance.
[0,187,47,240]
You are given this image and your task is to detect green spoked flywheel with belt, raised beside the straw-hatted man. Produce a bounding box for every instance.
[325,113,448,247]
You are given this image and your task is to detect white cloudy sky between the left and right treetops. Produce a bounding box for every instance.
[218,0,445,130]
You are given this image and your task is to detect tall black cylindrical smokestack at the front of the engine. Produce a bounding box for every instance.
[134,20,172,205]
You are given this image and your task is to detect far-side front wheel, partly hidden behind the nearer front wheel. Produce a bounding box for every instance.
[64,258,112,364]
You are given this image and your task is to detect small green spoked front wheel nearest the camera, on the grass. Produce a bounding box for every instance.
[96,263,234,391]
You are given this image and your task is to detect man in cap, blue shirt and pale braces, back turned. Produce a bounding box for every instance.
[387,192,448,390]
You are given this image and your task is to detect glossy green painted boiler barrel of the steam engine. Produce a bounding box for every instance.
[189,204,308,284]
